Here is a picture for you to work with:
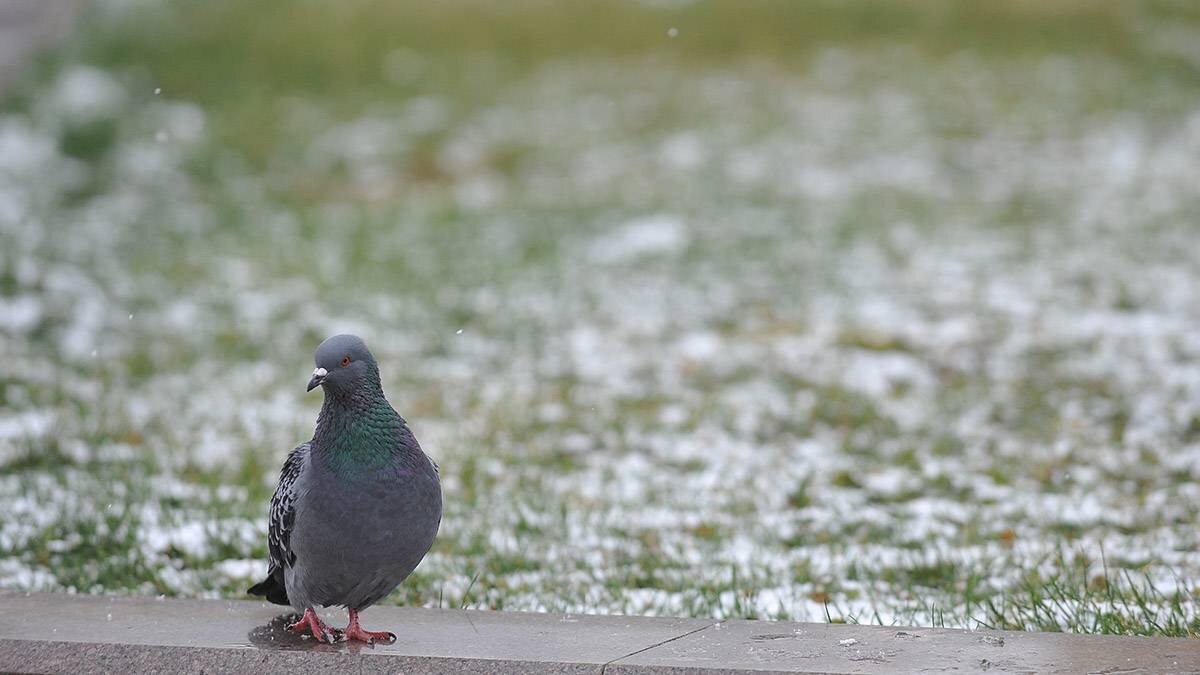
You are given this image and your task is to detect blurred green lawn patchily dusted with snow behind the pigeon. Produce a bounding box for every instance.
[0,0,1200,634]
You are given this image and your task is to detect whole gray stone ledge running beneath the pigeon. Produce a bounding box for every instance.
[0,593,1200,675]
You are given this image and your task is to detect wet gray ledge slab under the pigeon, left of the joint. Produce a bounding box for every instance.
[0,593,709,673]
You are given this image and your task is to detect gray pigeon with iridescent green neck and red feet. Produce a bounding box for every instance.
[250,335,442,644]
